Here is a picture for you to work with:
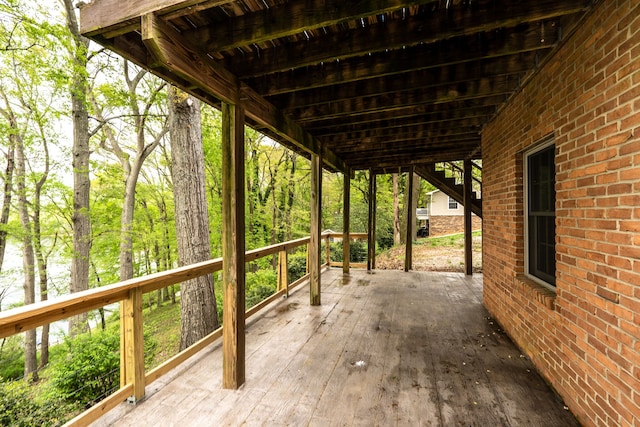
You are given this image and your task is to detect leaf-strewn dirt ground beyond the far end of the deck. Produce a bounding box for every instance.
[376,236,482,273]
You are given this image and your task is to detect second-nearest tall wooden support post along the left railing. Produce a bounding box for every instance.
[309,154,322,305]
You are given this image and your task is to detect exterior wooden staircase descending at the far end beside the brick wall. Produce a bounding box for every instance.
[415,162,482,218]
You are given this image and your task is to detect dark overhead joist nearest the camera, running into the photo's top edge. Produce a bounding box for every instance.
[185,0,437,53]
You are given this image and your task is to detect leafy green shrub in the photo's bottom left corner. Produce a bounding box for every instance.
[0,378,73,427]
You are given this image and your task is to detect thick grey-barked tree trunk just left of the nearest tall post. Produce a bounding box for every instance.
[168,88,219,350]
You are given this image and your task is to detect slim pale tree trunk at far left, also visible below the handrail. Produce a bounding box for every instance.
[16,134,38,381]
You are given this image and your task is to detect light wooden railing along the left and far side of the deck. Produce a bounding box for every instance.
[0,233,366,426]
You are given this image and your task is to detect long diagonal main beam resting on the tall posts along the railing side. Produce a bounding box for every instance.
[136,14,344,171]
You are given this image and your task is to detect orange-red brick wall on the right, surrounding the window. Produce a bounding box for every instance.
[482,0,640,426]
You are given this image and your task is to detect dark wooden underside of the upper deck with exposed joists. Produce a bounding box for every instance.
[81,0,592,174]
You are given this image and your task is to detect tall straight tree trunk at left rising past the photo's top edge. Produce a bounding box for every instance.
[64,0,91,336]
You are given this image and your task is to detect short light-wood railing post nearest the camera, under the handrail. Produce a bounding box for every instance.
[120,288,145,403]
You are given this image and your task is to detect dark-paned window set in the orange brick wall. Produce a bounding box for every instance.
[524,140,556,287]
